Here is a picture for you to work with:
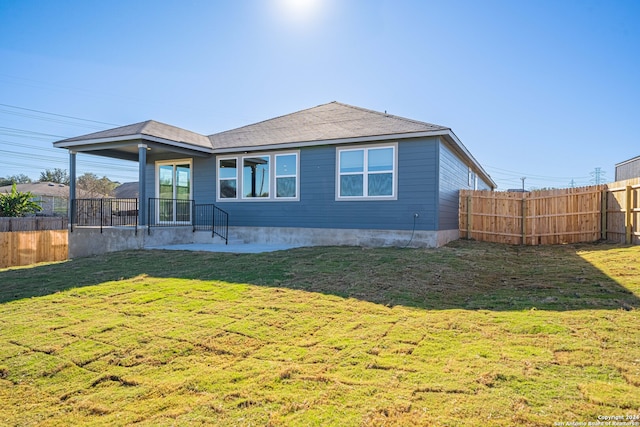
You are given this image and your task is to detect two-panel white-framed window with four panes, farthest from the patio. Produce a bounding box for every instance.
[336,144,398,200]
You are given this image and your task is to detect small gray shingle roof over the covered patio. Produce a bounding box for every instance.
[58,120,211,148]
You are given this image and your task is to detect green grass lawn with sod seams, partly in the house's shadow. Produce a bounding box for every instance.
[0,241,640,426]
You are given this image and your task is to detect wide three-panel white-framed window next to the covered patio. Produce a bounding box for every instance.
[216,152,300,202]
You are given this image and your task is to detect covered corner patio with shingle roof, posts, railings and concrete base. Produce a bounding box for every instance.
[53,120,228,256]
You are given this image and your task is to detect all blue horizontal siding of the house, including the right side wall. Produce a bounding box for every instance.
[146,137,480,231]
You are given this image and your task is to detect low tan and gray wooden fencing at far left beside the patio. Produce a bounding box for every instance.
[0,218,69,268]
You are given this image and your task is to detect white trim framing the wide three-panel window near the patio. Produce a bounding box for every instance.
[216,150,300,203]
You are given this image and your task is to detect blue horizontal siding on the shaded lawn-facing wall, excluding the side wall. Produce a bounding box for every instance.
[210,138,437,230]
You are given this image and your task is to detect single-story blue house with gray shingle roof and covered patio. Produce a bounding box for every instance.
[54,102,496,252]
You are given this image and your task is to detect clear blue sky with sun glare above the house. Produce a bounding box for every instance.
[0,0,640,190]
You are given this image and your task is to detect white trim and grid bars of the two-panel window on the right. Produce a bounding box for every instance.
[335,142,398,202]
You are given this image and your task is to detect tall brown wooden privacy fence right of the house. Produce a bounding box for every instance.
[459,178,640,245]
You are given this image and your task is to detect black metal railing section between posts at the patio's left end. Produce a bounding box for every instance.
[71,199,138,233]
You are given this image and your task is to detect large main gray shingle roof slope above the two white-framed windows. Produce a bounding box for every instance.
[209,101,449,149]
